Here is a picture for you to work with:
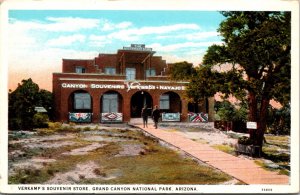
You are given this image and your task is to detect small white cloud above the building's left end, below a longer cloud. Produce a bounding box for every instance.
[47,34,85,46]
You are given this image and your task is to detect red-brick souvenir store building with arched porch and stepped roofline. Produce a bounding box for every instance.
[53,44,214,123]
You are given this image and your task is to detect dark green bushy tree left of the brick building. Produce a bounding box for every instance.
[8,78,52,129]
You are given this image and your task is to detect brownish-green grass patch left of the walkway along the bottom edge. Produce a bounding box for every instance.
[91,148,231,184]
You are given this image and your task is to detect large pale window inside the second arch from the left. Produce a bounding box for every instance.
[102,94,118,113]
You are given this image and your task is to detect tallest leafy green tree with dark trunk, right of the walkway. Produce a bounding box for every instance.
[203,12,291,146]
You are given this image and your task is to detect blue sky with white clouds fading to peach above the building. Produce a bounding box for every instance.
[8,10,224,91]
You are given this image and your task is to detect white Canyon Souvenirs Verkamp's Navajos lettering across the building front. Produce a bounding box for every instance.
[61,81,185,92]
